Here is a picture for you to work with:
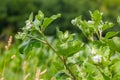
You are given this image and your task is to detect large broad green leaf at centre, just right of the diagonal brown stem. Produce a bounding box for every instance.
[57,40,83,57]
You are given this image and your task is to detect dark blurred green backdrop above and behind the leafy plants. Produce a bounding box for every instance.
[0,0,120,35]
